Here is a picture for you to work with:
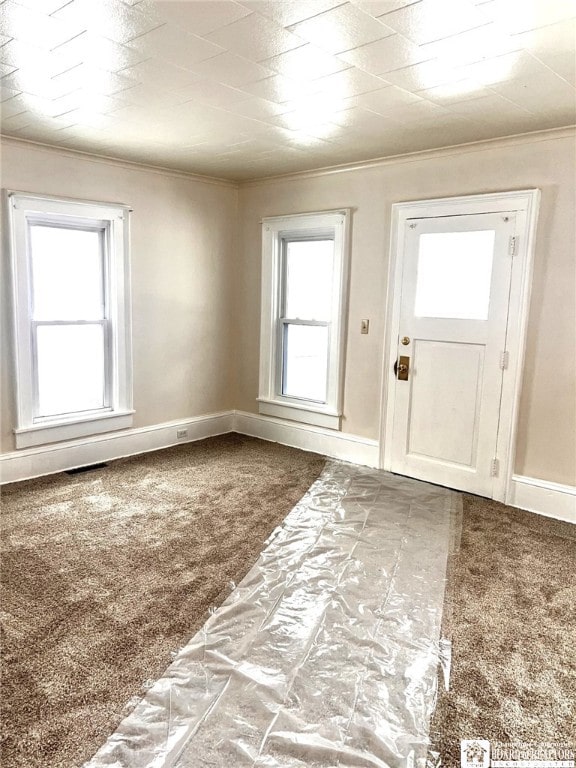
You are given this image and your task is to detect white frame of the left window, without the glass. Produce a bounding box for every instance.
[6,190,134,449]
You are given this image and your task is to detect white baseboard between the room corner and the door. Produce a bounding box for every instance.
[234,411,380,467]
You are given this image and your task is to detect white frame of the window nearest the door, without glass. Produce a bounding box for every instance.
[258,209,350,429]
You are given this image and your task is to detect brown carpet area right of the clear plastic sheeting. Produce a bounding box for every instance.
[432,496,576,768]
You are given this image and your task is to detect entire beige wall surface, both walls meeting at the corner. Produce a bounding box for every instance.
[0,129,576,484]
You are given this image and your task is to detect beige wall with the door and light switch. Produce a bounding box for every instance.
[237,129,576,484]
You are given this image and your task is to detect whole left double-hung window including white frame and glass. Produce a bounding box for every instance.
[8,192,133,448]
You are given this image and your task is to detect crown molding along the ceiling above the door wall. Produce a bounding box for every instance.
[238,125,576,189]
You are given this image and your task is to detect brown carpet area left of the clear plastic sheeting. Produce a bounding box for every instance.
[1,435,324,768]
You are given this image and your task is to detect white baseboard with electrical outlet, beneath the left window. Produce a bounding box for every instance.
[0,411,234,483]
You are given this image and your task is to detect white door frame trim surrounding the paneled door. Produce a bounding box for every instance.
[380,189,540,503]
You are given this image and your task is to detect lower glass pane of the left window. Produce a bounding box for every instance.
[37,325,105,416]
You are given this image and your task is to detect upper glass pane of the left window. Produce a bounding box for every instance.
[30,225,103,320]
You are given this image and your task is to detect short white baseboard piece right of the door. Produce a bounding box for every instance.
[508,475,576,523]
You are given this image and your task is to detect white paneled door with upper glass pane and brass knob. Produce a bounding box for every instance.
[390,212,517,497]
